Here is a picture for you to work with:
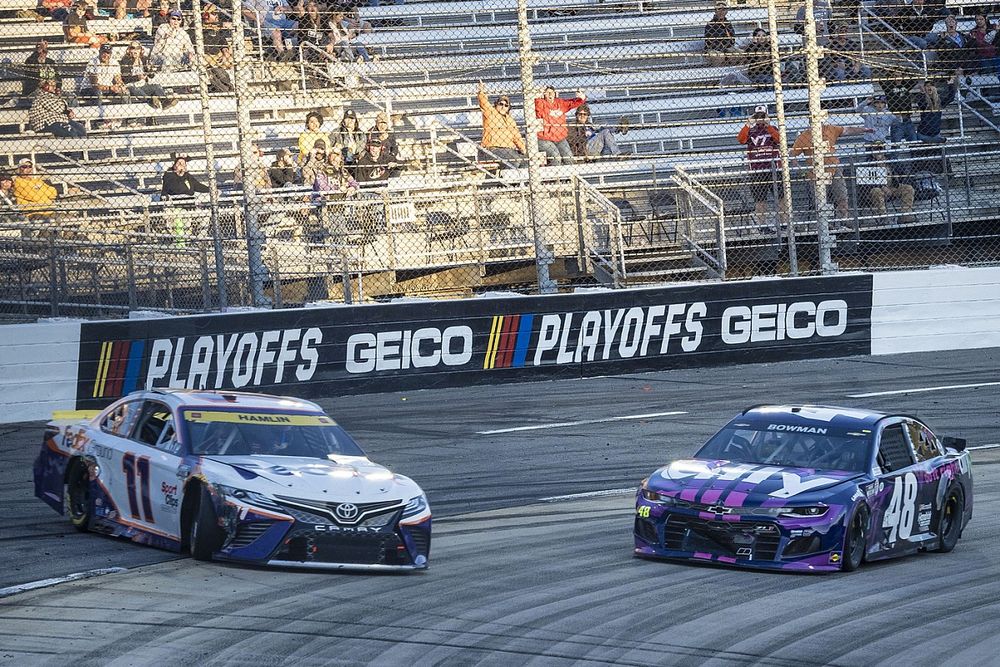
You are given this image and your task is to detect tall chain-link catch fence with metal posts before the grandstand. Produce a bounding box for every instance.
[0,0,1000,318]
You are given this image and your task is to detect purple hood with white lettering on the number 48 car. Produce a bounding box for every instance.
[647,459,864,507]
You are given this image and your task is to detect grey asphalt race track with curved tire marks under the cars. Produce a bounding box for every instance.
[0,350,1000,667]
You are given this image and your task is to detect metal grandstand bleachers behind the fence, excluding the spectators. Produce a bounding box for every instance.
[0,0,1000,316]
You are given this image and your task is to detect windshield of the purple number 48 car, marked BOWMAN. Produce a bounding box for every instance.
[695,423,871,472]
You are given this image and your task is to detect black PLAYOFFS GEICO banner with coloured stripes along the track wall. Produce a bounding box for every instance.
[77,275,872,409]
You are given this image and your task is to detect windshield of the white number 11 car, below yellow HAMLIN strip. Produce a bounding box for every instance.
[183,410,365,459]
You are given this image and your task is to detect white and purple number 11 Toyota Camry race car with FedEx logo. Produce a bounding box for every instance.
[34,390,431,570]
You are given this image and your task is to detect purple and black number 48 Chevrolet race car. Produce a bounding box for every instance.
[635,405,972,572]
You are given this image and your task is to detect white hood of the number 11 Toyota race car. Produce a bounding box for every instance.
[203,456,421,502]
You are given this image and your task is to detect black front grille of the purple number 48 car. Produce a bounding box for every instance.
[663,514,781,560]
